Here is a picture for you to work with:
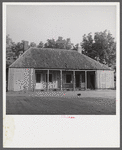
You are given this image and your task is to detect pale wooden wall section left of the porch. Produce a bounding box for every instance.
[8,68,35,91]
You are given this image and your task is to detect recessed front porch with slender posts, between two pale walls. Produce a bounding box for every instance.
[34,69,95,91]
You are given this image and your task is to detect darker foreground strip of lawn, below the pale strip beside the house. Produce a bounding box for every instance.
[6,96,116,115]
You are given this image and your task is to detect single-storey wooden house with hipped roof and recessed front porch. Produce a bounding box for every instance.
[8,48,114,91]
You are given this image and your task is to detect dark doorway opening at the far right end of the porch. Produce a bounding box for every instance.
[87,71,95,89]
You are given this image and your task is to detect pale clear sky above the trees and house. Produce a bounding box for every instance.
[6,5,116,44]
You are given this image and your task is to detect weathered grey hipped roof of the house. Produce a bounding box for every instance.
[10,48,110,70]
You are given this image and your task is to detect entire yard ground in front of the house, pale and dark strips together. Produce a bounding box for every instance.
[6,90,116,115]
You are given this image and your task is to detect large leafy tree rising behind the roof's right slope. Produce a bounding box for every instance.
[81,30,116,66]
